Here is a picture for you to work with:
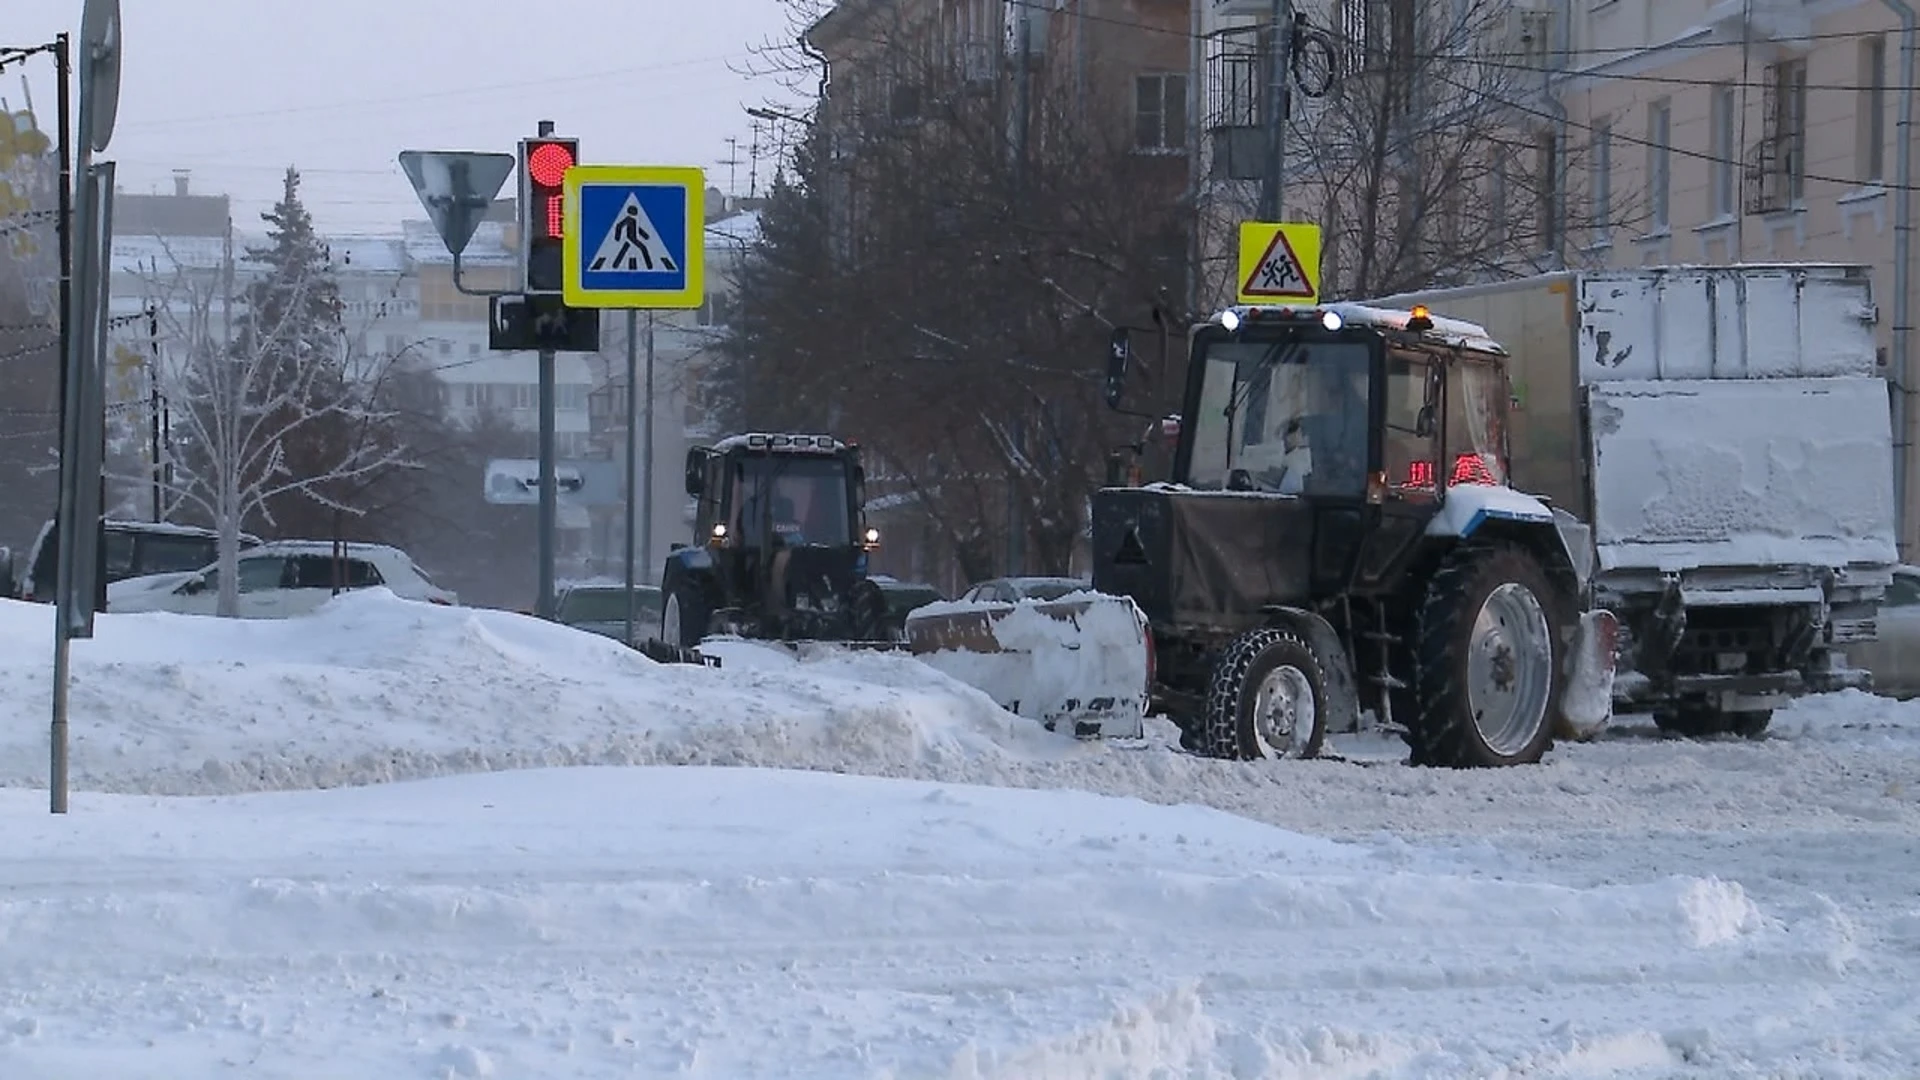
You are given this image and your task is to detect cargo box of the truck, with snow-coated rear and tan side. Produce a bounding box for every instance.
[1380,263,1897,573]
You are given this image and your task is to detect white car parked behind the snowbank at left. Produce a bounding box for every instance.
[108,540,459,619]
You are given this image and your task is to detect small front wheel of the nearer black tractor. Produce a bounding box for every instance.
[1198,628,1327,759]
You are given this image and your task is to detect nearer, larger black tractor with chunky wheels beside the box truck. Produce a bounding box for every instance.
[1092,304,1617,767]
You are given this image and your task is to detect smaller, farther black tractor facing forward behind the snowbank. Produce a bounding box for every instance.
[660,432,900,650]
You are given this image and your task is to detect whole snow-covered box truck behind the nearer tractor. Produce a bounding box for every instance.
[1369,263,1897,736]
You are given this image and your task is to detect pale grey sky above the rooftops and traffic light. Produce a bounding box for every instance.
[0,0,810,231]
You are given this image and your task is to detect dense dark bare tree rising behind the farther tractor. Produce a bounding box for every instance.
[730,6,1190,578]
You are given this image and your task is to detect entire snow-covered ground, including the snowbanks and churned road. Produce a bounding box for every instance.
[0,594,1920,1078]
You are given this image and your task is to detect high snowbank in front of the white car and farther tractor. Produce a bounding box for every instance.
[0,590,1073,794]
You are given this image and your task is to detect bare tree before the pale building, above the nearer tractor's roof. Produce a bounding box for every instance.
[1204,0,1632,298]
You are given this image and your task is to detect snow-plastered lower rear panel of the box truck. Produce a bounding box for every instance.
[1592,379,1897,569]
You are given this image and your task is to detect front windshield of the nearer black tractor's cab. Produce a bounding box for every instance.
[1187,334,1371,496]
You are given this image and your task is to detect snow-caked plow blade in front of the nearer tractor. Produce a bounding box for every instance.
[906,592,1152,738]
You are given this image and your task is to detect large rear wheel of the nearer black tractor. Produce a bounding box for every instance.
[1405,542,1574,769]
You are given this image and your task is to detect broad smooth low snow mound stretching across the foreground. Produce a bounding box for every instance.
[0,769,1881,1080]
